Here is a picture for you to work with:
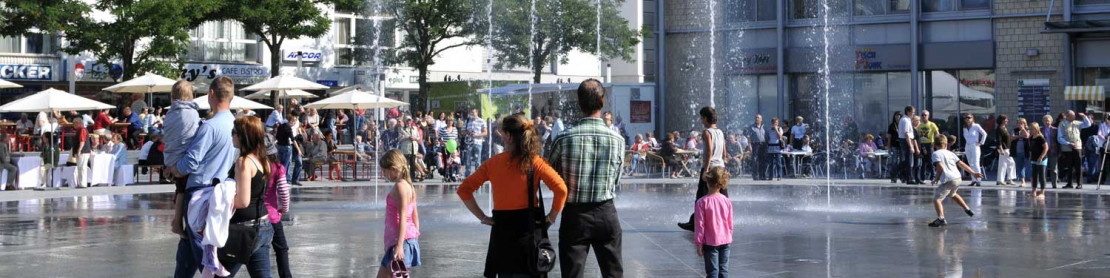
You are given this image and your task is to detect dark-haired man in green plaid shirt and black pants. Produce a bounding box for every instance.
[547,79,625,278]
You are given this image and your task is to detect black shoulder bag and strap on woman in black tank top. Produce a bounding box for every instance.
[212,169,270,266]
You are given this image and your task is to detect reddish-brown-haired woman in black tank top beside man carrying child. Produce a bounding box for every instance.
[224,117,274,277]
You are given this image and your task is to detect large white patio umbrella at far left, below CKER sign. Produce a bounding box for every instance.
[0,88,115,112]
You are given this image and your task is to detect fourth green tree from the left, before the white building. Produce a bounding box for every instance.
[385,0,487,96]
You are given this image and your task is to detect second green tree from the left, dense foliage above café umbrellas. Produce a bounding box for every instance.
[64,0,219,81]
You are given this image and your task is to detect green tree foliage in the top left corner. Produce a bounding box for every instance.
[0,0,89,37]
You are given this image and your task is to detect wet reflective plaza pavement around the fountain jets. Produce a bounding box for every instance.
[0,180,1110,277]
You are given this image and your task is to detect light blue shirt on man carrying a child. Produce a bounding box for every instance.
[178,111,239,189]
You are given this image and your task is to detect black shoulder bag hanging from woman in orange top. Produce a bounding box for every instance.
[527,170,555,275]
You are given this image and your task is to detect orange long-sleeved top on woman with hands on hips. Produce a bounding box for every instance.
[456,152,566,210]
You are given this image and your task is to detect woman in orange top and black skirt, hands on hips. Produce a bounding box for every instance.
[457,113,566,277]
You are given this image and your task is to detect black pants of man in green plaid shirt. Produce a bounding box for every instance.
[558,200,624,278]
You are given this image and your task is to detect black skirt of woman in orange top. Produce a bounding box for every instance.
[484,208,544,277]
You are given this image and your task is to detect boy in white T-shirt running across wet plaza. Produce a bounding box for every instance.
[929,136,982,227]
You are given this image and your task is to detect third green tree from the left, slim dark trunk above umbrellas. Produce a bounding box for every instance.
[212,0,361,103]
